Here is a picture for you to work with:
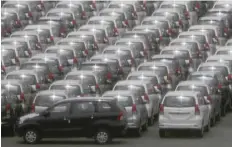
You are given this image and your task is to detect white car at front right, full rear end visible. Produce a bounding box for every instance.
[159,91,210,137]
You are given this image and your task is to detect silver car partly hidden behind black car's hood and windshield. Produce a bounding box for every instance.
[31,90,68,113]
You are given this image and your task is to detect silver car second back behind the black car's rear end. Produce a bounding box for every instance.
[113,80,159,125]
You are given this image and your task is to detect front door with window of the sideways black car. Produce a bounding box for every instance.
[38,102,72,137]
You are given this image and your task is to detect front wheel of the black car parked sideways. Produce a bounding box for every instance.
[23,129,41,144]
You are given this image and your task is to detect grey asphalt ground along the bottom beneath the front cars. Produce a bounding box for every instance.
[1,113,232,147]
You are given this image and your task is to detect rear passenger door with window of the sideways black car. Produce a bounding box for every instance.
[68,101,96,136]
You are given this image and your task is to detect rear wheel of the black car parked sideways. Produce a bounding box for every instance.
[94,129,112,144]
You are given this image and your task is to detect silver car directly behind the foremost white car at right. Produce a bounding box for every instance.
[175,81,221,126]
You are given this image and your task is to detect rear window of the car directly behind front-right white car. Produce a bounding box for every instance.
[177,85,208,96]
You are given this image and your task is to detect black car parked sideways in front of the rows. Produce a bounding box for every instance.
[16,97,127,144]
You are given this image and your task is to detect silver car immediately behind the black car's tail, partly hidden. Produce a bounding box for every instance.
[102,90,148,136]
